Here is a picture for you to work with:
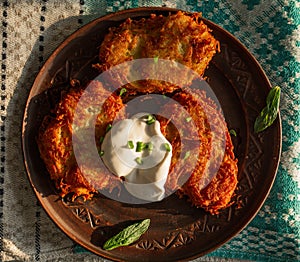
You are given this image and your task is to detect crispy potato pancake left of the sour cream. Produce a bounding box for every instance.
[37,81,124,200]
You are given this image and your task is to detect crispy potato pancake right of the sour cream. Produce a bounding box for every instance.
[159,89,238,214]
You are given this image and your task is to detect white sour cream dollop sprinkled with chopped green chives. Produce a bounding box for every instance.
[101,115,172,202]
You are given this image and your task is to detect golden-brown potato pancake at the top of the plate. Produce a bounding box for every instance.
[96,11,219,93]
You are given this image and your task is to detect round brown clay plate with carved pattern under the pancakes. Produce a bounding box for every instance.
[22,8,281,261]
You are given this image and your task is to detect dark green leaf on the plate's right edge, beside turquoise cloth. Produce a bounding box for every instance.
[254,86,280,133]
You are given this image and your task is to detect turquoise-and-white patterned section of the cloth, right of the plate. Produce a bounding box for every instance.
[79,0,300,261]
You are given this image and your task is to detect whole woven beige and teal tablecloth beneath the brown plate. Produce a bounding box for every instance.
[0,0,300,262]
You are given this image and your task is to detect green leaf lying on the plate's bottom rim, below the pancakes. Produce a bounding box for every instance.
[103,219,150,250]
